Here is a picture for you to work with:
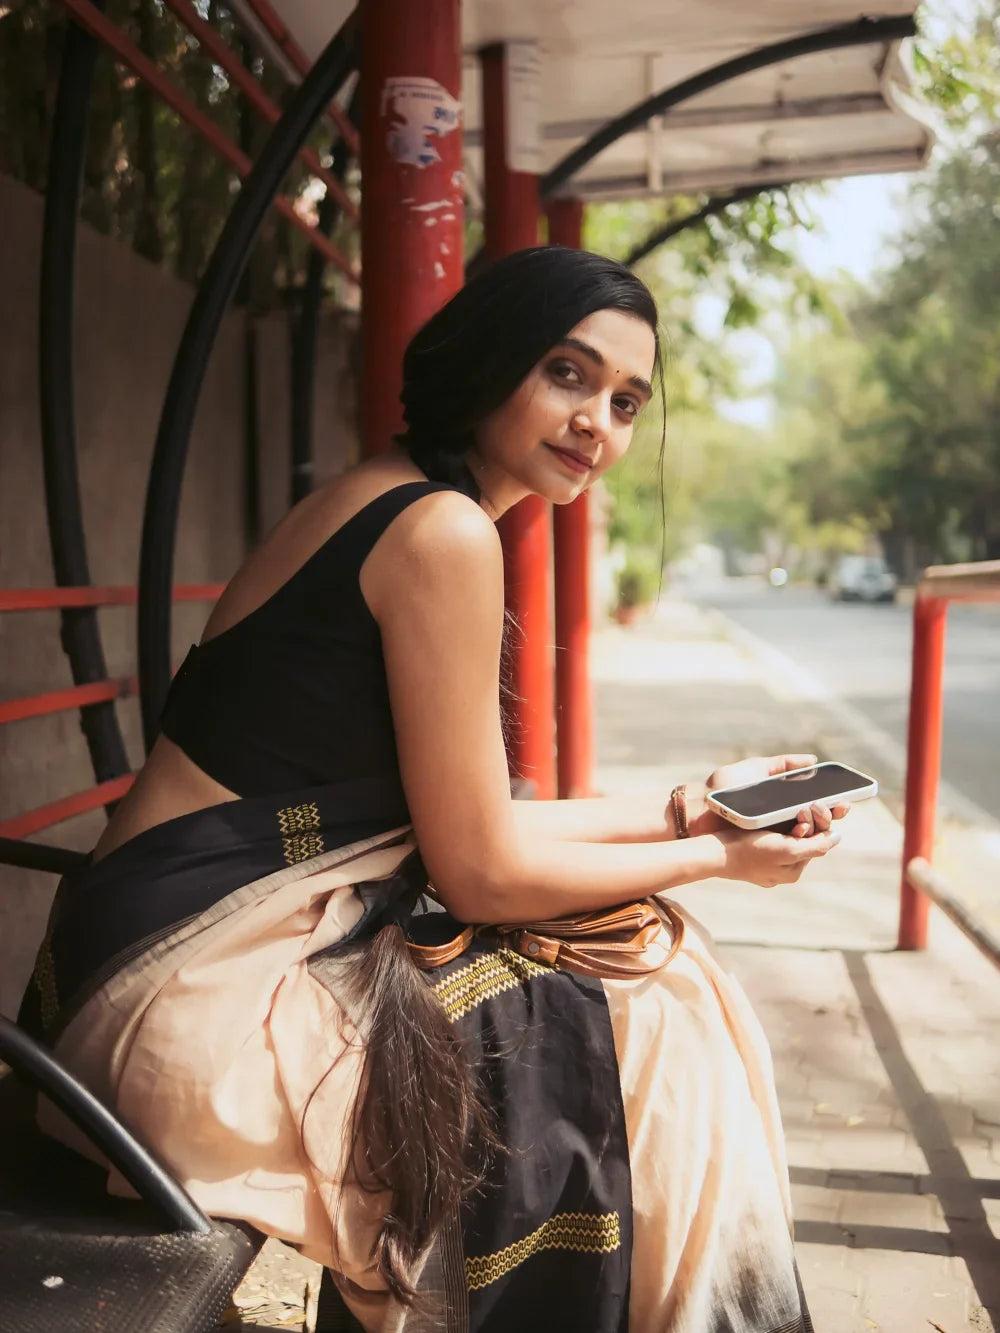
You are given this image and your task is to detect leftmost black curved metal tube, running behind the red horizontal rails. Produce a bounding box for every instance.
[39,0,129,789]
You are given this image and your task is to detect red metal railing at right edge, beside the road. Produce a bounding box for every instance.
[897,560,1000,966]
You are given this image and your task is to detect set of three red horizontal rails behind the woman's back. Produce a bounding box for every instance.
[0,584,225,838]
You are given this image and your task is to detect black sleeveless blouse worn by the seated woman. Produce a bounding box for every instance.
[161,481,455,818]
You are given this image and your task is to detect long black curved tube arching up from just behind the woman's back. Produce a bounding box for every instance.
[139,13,357,749]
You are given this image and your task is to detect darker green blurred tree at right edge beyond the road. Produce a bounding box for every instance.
[857,133,1000,559]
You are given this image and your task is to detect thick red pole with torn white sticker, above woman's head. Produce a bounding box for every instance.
[361,0,464,455]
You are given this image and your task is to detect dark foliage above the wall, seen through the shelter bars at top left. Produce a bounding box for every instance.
[0,0,352,305]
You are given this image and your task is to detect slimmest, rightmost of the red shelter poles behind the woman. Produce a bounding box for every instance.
[545,199,593,797]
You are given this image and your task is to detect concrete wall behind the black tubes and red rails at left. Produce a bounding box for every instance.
[0,176,356,1013]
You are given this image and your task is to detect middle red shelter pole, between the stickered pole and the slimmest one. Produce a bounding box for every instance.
[481,45,556,800]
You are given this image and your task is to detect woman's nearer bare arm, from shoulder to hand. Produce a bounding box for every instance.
[361,492,832,921]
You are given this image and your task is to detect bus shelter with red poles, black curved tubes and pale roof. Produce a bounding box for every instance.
[0,0,932,895]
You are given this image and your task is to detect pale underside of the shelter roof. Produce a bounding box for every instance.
[256,0,933,209]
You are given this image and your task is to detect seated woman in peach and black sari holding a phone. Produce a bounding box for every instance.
[27,248,844,1333]
